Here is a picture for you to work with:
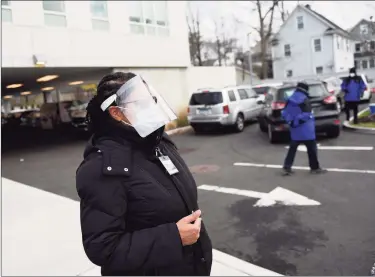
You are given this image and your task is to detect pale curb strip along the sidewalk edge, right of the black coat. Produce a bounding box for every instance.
[212,249,283,276]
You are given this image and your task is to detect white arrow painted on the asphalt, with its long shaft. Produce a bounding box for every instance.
[198,185,320,207]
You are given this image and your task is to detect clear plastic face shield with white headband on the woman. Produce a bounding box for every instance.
[101,75,177,138]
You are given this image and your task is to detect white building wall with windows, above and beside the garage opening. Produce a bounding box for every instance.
[2,1,190,111]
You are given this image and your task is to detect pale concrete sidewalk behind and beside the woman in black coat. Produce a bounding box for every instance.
[1,178,281,276]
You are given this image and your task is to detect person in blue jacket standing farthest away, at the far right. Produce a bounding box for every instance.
[341,67,366,124]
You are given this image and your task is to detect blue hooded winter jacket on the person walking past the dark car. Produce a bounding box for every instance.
[282,89,316,141]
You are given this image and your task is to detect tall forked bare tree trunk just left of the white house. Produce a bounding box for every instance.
[253,0,279,78]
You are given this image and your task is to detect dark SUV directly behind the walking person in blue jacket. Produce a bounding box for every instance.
[258,78,341,143]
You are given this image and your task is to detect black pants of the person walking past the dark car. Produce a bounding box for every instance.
[284,140,320,169]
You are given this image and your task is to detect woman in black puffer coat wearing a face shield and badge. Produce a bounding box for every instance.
[76,72,212,276]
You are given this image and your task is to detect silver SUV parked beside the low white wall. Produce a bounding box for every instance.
[188,86,261,132]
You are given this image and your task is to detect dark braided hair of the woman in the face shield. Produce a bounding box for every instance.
[86,72,136,134]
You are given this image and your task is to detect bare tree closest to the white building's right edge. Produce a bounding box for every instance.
[186,3,203,66]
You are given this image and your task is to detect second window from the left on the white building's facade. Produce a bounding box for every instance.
[43,0,66,27]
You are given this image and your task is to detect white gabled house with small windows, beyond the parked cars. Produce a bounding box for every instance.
[272,5,354,79]
